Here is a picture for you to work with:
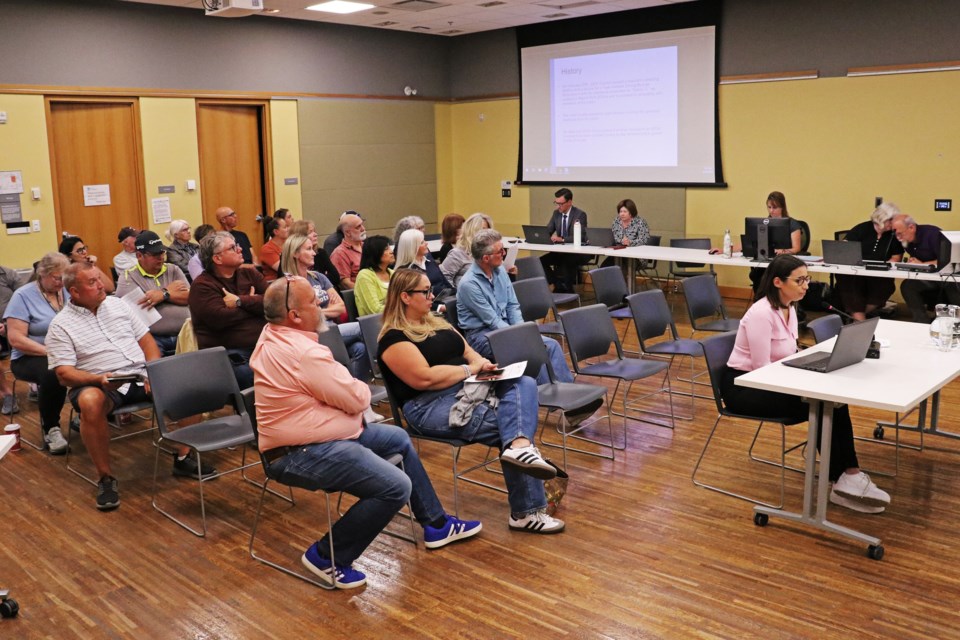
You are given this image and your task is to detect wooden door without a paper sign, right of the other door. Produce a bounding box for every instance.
[197,101,273,245]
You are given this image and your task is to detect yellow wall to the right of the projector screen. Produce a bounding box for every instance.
[687,72,960,284]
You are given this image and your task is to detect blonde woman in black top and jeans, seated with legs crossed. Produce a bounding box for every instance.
[377,269,564,533]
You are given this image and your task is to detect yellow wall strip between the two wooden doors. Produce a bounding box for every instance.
[140,98,203,242]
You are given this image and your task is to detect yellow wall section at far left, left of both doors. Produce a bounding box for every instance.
[0,94,58,269]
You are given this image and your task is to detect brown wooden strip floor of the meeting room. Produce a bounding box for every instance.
[0,292,960,640]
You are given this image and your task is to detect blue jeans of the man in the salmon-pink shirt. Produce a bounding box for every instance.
[269,424,444,566]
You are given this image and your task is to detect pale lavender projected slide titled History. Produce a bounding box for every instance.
[550,47,678,167]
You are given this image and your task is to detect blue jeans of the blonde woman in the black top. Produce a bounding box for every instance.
[403,376,547,516]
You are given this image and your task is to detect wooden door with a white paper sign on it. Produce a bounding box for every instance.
[47,97,147,264]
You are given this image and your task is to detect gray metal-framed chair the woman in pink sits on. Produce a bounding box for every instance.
[690,331,806,509]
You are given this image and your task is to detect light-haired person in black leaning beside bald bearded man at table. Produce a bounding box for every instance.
[837,202,903,320]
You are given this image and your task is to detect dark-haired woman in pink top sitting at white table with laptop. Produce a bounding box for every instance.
[720,255,890,513]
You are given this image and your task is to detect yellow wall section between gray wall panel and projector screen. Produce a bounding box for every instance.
[437,100,530,235]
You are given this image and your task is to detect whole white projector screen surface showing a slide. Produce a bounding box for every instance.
[517,26,722,185]
